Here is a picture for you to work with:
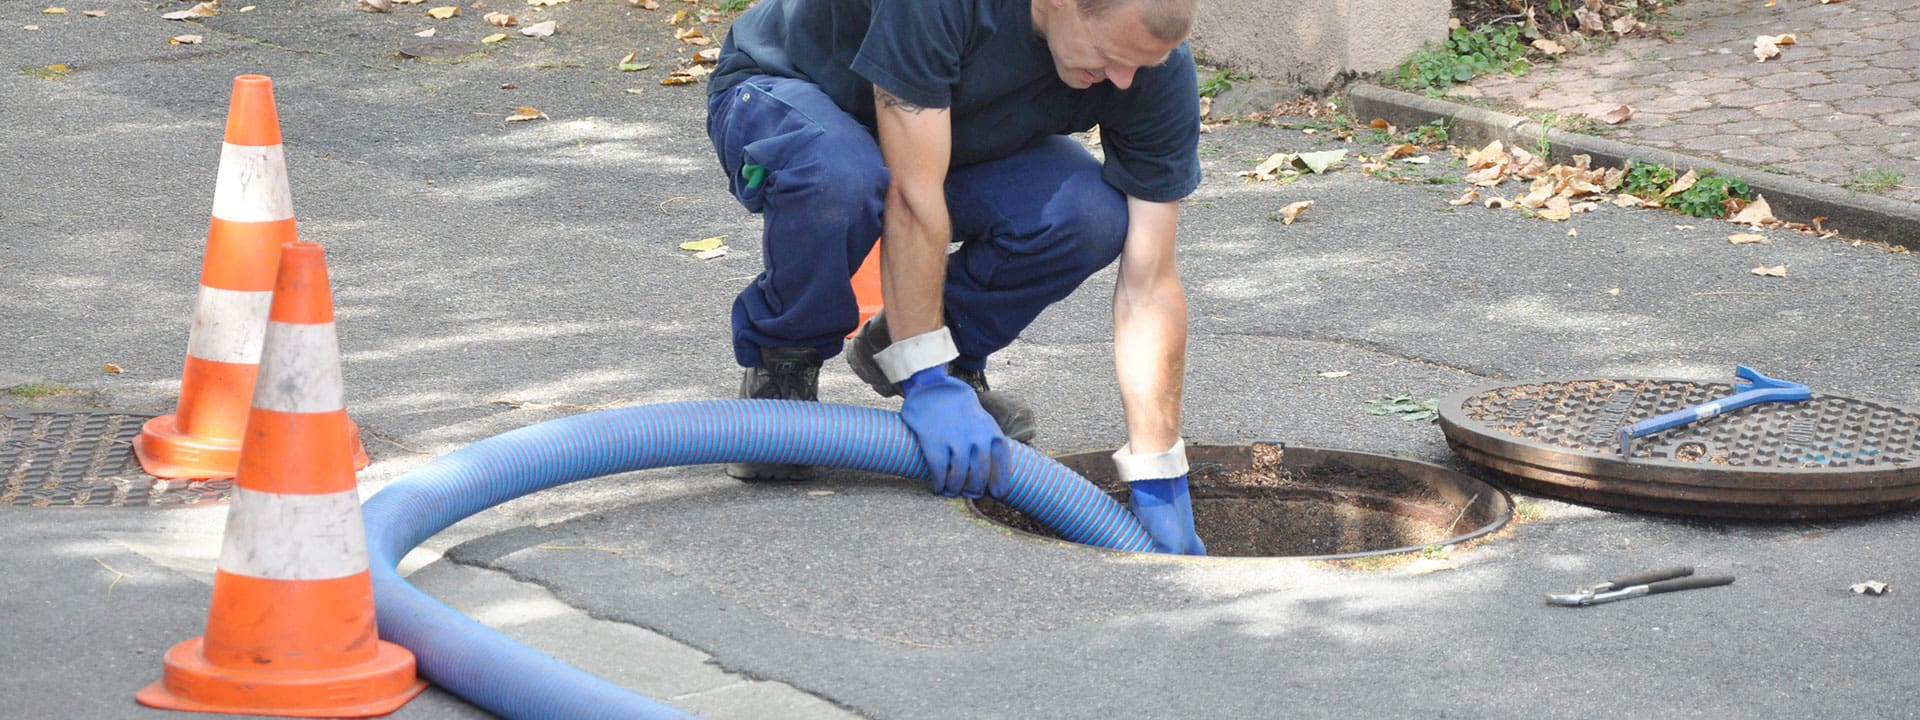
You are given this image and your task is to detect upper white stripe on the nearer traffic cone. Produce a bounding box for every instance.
[253,323,348,413]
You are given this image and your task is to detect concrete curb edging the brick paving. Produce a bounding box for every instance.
[1348,84,1920,252]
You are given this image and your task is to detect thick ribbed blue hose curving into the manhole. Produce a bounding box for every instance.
[363,399,1154,720]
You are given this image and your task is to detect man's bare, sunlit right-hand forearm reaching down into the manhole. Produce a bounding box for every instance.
[1114,198,1187,453]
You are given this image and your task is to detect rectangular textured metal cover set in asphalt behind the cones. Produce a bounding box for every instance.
[0,411,232,507]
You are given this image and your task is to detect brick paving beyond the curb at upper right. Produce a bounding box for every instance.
[1452,0,1920,202]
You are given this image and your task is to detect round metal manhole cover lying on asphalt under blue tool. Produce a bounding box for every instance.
[1440,378,1920,518]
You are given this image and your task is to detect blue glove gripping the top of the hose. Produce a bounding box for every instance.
[900,365,1014,499]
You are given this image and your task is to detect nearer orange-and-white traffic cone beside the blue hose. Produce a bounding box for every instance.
[136,242,426,718]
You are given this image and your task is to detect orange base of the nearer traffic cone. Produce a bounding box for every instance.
[134,637,426,718]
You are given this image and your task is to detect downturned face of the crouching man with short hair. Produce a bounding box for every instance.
[1041,0,1181,90]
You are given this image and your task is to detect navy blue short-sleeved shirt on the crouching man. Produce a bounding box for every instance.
[708,0,1200,202]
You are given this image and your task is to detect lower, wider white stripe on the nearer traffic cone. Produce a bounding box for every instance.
[221,488,367,580]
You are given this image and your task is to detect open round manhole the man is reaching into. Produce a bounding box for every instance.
[973,444,1513,559]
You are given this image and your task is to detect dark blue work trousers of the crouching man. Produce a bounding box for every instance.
[707,75,1127,371]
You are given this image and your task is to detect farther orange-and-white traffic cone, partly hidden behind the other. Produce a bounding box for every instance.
[132,75,369,480]
